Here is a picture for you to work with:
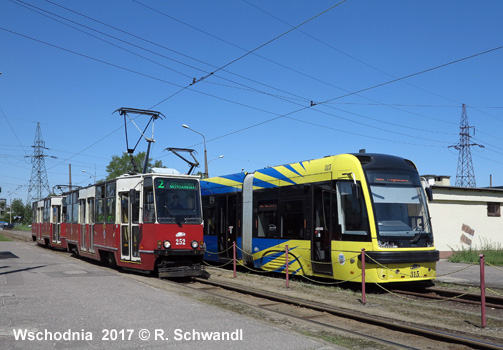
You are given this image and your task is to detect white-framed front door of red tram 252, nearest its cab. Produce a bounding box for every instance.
[119,190,141,261]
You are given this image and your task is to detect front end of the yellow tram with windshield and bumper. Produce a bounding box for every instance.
[333,154,439,283]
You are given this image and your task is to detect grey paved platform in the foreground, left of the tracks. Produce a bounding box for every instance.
[0,242,336,350]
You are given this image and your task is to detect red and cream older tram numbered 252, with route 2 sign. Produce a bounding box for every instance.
[32,173,209,278]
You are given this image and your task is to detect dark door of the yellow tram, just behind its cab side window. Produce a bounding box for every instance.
[311,183,337,275]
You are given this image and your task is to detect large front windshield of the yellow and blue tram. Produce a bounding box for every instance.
[367,171,431,247]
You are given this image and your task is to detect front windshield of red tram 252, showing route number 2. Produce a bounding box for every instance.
[154,177,201,225]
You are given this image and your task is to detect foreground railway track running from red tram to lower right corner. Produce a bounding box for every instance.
[183,279,503,349]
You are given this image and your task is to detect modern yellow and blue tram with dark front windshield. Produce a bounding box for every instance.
[201,153,439,283]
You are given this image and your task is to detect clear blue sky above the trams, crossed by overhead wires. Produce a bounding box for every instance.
[0,0,503,201]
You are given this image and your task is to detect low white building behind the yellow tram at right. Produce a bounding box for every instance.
[423,175,503,258]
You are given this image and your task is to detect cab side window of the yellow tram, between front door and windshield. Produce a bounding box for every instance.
[337,181,369,240]
